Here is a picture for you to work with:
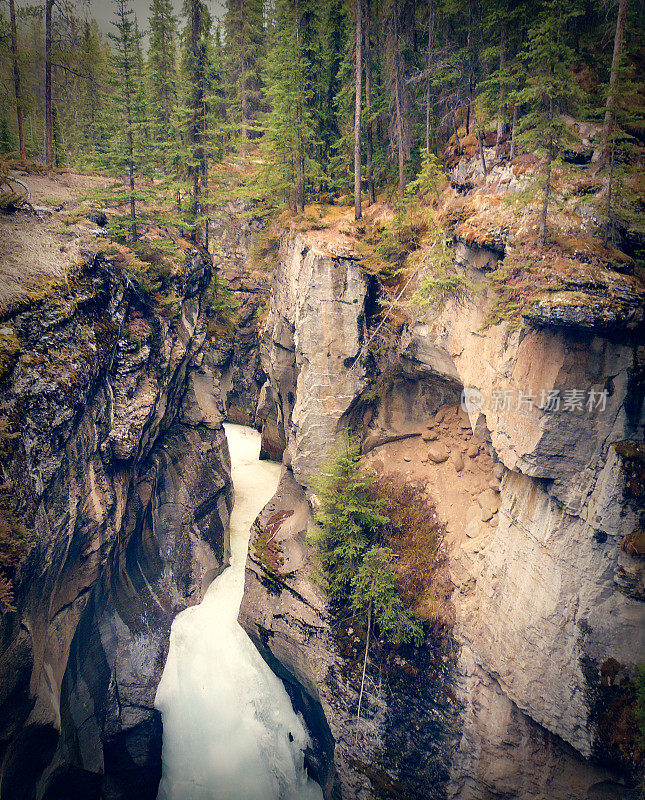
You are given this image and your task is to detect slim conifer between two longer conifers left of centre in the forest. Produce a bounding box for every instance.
[148,0,178,172]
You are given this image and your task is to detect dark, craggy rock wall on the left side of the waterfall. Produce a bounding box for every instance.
[0,247,231,799]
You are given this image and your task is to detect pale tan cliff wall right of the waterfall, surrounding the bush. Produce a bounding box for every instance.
[241,225,645,800]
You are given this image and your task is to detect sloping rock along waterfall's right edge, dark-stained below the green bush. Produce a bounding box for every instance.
[240,470,457,800]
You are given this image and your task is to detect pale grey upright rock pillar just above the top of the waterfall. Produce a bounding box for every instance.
[259,228,367,486]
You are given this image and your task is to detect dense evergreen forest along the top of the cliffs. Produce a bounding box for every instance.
[0,0,645,253]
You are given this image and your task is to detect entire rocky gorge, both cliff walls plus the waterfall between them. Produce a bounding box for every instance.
[0,167,645,800]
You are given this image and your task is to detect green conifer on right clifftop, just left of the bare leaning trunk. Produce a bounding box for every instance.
[519,0,581,247]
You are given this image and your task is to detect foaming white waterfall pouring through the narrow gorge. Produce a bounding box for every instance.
[155,425,322,800]
